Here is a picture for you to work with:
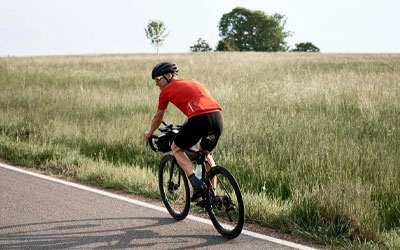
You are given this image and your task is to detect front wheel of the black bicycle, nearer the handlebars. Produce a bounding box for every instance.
[158,155,190,220]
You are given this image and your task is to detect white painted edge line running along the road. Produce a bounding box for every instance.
[0,163,315,250]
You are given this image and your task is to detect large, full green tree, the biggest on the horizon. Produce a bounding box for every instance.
[217,7,291,51]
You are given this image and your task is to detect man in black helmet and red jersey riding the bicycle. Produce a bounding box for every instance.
[144,62,224,201]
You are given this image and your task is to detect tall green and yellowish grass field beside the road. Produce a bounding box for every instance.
[0,53,400,249]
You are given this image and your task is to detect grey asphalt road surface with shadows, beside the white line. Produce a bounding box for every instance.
[0,166,314,250]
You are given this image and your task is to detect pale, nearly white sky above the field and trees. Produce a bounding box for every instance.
[0,0,400,57]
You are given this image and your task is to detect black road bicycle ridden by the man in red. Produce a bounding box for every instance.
[149,121,244,239]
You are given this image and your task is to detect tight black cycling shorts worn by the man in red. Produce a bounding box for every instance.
[174,111,224,152]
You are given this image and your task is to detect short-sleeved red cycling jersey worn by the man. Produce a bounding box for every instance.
[158,79,222,118]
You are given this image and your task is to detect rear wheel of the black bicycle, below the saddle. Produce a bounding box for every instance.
[206,166,244,239]
